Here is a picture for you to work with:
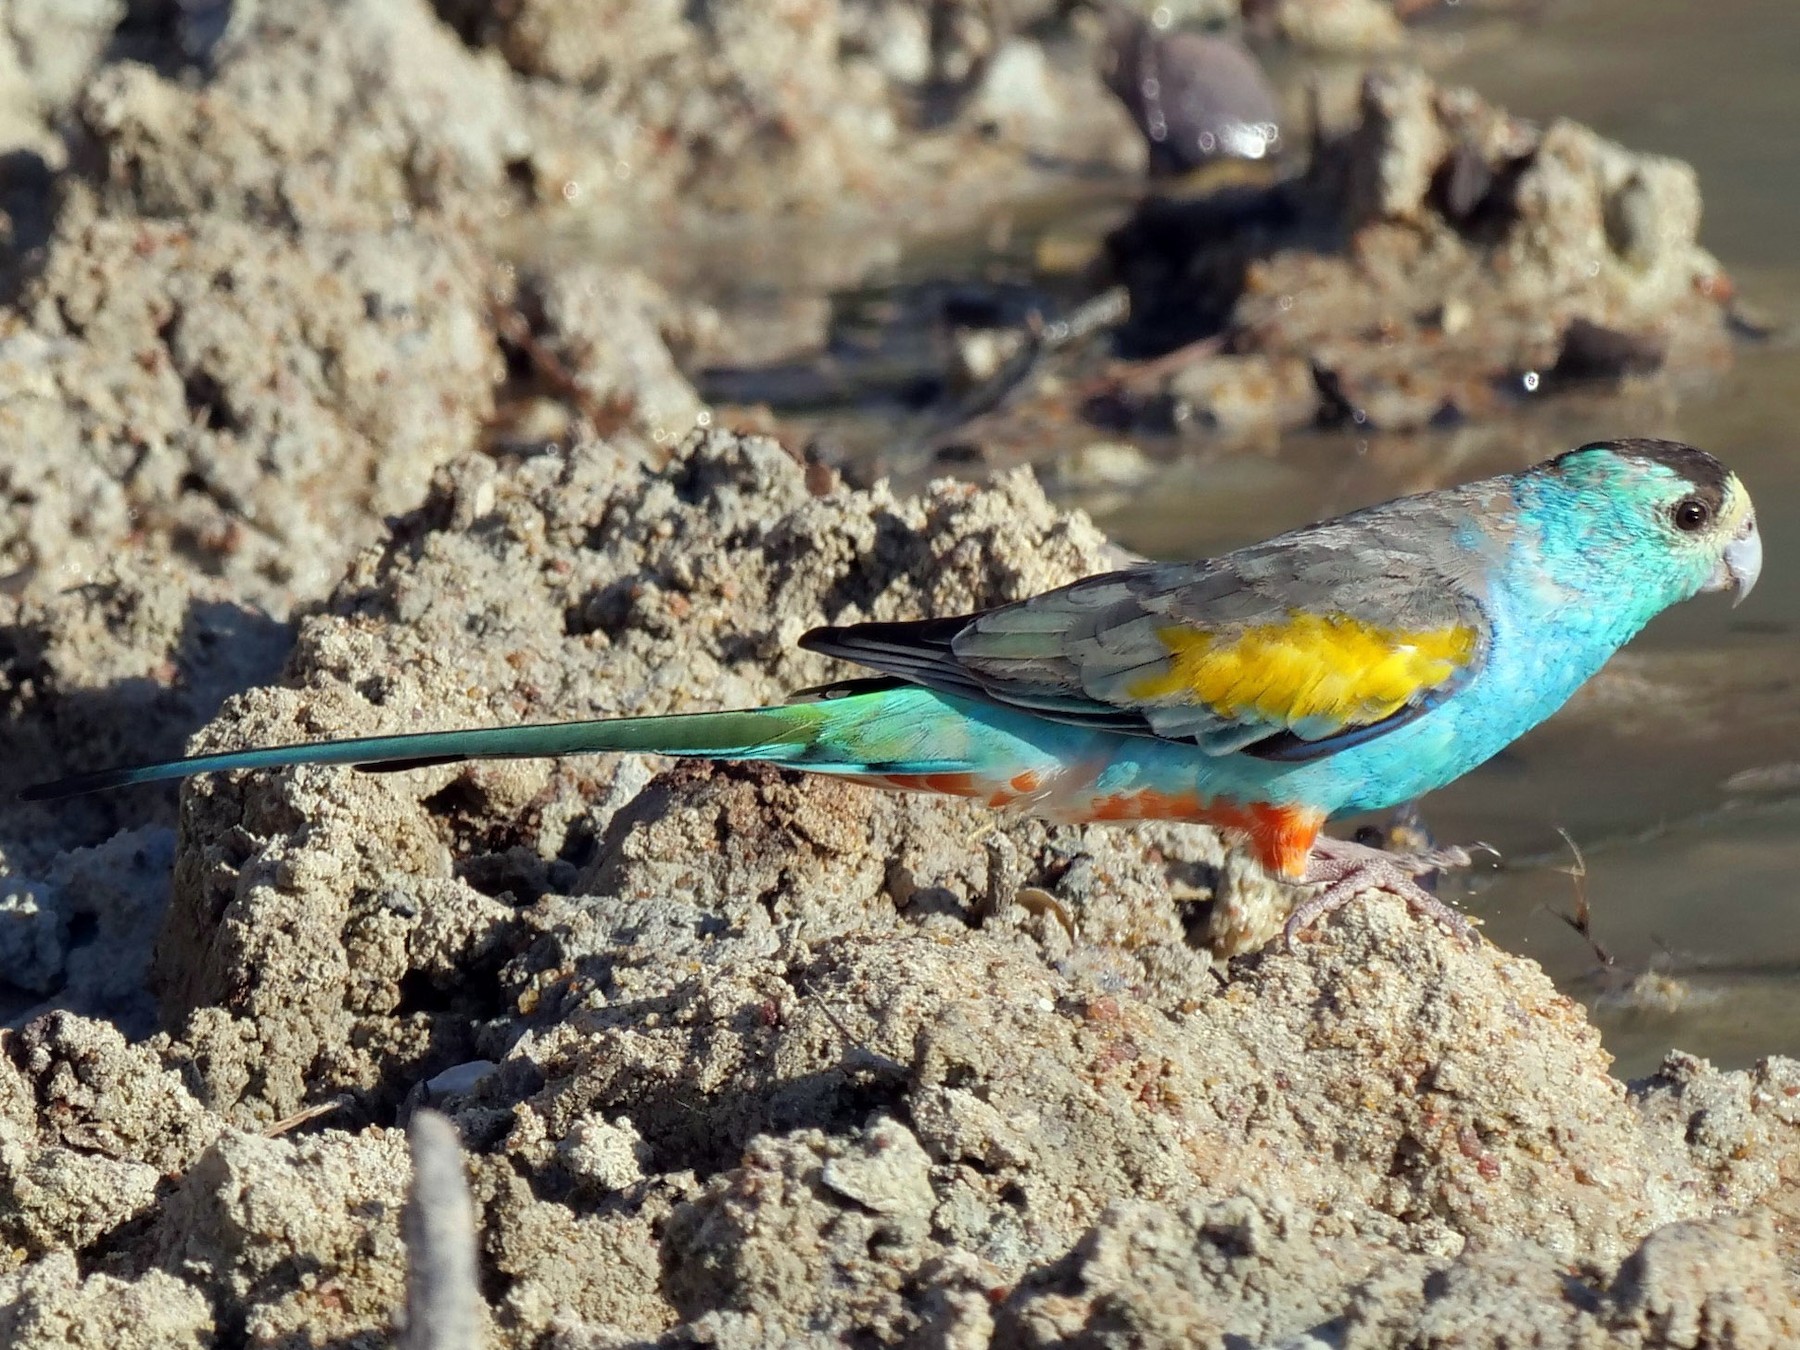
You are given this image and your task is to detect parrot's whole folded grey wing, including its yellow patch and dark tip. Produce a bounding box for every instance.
[801,482,1510,760]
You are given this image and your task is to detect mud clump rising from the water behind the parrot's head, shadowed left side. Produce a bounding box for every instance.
[1111,70,1730,432]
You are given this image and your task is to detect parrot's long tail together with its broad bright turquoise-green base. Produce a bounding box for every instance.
[18,686,1015,801]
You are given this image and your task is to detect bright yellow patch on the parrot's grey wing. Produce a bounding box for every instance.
[1130,610,1476,725]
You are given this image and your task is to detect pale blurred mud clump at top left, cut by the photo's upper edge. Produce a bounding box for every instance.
[74,0,531,229]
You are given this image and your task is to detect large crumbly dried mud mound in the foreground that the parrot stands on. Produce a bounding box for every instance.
[0,434,1800,1346]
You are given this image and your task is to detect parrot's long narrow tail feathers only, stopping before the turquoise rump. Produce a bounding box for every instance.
[18,700,864,801]
